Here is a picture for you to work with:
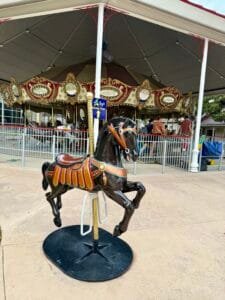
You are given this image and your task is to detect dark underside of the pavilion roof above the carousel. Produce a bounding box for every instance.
[0,5,225,93]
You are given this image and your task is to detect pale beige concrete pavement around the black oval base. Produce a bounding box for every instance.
[0,164,225,300]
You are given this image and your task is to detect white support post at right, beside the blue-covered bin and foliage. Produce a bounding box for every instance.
[191,38,209,172]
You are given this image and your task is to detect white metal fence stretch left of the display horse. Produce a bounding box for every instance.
[0,126,88,166]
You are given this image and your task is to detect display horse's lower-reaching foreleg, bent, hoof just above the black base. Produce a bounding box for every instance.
[104,190,135,236]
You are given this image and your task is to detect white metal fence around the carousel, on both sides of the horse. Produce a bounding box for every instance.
[0,126,225,173]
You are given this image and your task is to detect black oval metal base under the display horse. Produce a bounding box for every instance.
[43,225,133,282]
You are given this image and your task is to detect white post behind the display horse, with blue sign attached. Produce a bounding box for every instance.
[94,3,104,148]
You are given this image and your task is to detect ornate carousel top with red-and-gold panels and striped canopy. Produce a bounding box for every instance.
[0,62,186,113]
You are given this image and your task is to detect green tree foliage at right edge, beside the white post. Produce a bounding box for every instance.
[203,95,225,122]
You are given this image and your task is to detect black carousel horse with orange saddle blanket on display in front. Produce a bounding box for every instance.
[42,117,145,236]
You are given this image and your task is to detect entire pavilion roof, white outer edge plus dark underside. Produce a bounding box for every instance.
[0,0,225,93]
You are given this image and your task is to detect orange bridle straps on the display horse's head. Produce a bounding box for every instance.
[108,123,137,154]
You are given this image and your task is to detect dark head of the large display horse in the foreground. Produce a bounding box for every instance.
[107,117,138,161]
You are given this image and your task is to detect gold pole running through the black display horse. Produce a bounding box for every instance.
[87,93,99,241]
